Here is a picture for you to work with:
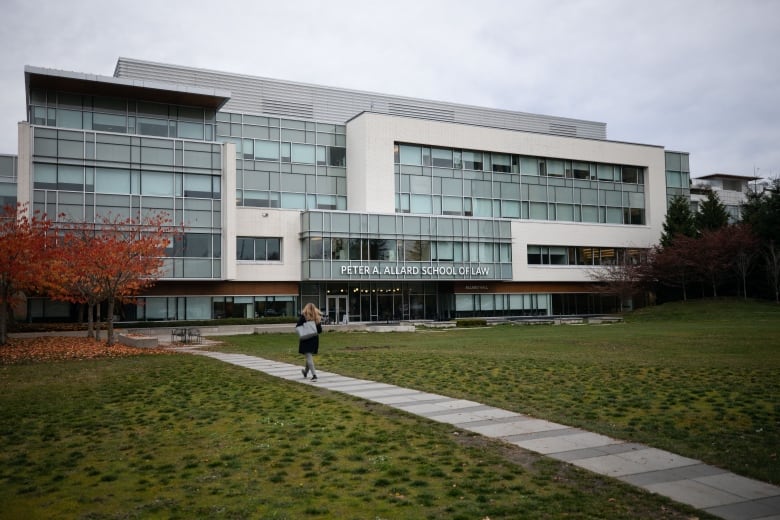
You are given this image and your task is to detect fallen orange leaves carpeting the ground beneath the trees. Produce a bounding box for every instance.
[0,336,172,365]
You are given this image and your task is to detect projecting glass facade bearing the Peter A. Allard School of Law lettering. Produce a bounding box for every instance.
[301,211,512,280]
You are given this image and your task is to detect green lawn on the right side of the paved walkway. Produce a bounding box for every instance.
[212,300,780,484]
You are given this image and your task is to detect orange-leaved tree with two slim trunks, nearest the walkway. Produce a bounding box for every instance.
[49,214,176,345]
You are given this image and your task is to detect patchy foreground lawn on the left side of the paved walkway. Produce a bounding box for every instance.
[0,342,720,520]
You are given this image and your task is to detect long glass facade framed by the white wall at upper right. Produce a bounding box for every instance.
[395,143,645,225]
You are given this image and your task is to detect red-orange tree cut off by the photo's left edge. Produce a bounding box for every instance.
[0,203,51,345]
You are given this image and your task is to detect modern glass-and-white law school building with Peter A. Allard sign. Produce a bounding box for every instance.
[6,58,690,321]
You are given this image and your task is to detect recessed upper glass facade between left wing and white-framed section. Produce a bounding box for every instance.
[217,112,347,210]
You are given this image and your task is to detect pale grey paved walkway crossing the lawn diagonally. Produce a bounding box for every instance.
[177,348,780,520]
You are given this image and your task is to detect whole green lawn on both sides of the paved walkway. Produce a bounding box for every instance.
[0,302,780,520]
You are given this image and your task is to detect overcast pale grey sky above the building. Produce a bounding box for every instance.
[0,0,780,178]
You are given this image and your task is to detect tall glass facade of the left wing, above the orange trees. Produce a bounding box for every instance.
[29,90,222,279]
